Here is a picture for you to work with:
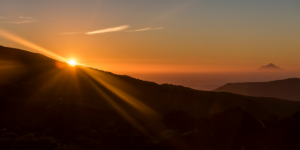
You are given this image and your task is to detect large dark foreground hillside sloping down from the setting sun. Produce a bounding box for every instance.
[0,47,300,150]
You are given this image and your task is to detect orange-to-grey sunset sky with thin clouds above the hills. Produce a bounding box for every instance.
[0,0,300,74]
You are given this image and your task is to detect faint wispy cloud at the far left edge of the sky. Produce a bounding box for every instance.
[0,16,38,24]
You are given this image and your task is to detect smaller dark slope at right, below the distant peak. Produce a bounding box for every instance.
[214,78,300,101]
